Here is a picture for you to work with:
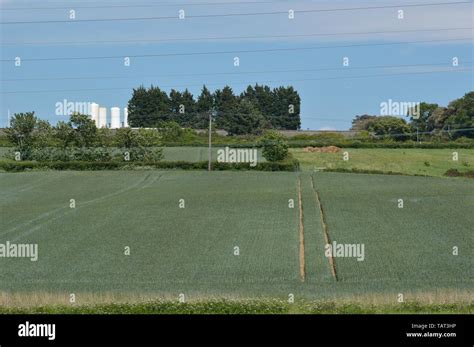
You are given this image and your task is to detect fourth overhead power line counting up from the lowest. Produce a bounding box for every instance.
[1,27,473,46]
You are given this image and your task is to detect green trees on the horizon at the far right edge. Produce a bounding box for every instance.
[351,92,474,140]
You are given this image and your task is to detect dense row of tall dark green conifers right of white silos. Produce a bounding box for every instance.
[128,84,301,135]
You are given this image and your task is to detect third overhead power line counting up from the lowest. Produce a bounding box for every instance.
[0,37,473,63]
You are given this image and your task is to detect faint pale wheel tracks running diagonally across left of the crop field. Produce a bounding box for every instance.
[0,172,157,241]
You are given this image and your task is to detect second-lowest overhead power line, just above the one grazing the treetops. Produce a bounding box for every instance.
[0,61,473,82]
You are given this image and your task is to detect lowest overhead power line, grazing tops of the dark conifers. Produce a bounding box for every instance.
[0,68,474,94]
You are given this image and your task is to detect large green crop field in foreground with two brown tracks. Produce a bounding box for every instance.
[0,170,474,305]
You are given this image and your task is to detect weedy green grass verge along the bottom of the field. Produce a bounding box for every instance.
[0,300,474,314]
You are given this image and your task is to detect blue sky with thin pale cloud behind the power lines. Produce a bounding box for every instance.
[0,0,474,130]
